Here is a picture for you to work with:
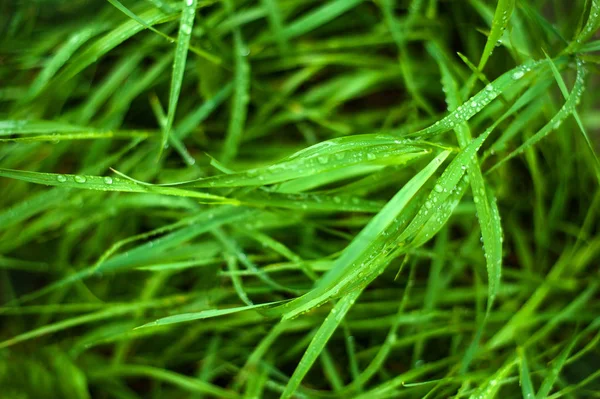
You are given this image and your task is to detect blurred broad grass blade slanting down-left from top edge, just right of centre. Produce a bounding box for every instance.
[283,0,363,39]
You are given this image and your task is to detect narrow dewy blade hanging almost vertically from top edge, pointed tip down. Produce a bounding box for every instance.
[159,0,198,158]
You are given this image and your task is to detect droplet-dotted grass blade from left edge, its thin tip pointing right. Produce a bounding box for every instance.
[0,169,239,204]
